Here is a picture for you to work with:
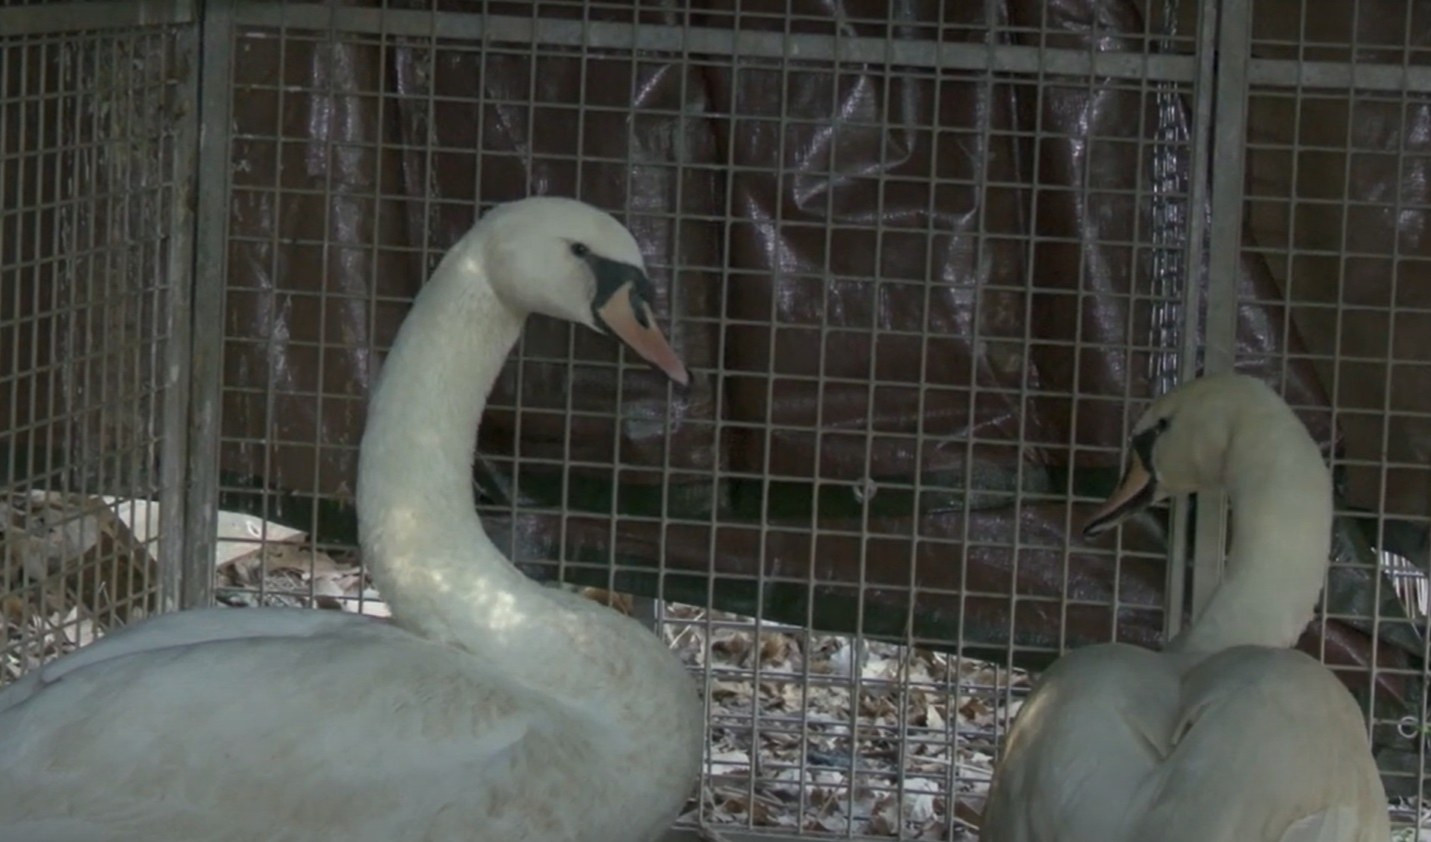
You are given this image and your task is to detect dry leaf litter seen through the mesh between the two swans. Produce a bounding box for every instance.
[667,606,1027,839]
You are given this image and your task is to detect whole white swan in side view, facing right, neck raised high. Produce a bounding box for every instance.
[0,198,703,842]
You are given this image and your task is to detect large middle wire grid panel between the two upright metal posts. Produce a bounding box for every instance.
[200,3,1196,838]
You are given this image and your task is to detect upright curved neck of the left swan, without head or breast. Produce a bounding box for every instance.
[358,231,550,657]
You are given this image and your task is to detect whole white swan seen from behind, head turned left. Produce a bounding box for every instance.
[980,375,1391,842]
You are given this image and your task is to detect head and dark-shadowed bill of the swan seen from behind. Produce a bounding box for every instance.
[1083,374,1293,538]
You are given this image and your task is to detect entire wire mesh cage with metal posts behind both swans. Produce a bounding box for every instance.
[0,0,1431,839]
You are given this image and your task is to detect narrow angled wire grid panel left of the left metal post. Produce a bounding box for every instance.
[0,7,193,684]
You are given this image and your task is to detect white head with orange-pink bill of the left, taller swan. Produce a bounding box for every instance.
[478,196,690,385]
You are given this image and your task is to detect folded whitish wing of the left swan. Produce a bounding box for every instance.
[0,624,595,842]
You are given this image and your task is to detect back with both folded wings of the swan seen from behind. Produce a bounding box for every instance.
[980,644,1391,842]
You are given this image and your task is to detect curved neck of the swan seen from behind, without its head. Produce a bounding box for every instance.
[1169,411,1332,653]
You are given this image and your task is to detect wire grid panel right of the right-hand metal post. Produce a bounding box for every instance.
[1238,0,1431,839]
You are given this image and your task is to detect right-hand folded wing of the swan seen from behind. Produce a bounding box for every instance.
[1132,647,1391,842]
